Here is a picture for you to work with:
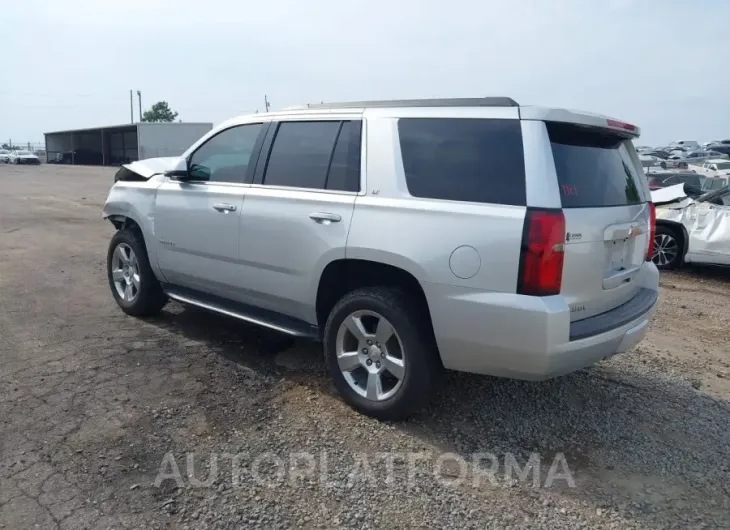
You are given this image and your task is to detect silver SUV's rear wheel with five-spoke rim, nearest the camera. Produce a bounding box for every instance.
[324,287,443,420]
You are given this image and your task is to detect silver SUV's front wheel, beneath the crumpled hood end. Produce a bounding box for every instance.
[106,229,167,317]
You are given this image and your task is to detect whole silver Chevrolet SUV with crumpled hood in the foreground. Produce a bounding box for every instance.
[104,98,659,419]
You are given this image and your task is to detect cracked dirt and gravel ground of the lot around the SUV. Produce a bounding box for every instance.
[0,165,730,529]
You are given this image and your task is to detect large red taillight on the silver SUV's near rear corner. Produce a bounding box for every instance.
[517,208,565,296]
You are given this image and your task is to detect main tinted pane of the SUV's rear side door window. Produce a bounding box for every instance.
[264,121,340,189]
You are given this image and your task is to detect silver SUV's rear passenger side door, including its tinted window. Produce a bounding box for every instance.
[238,117,362,323]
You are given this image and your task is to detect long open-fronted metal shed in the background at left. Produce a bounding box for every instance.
[45,122,213,166]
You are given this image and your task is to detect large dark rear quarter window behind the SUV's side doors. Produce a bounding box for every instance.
[398,118,525,205]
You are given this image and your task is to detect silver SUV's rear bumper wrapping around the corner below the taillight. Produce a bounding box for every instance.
[424,265,659,380]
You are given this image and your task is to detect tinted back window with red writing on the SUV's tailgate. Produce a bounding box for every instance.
[546,123,642,208]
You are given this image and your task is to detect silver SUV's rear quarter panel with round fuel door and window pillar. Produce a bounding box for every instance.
[346,109,526,293]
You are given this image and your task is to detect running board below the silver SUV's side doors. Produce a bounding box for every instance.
[163,284,320,340]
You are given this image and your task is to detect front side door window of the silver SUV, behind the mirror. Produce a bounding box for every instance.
[188,123,262,182]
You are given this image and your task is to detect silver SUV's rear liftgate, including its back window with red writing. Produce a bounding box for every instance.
[546,123,649,320]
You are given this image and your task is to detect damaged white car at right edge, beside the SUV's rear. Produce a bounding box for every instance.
[651,184,730,270]
